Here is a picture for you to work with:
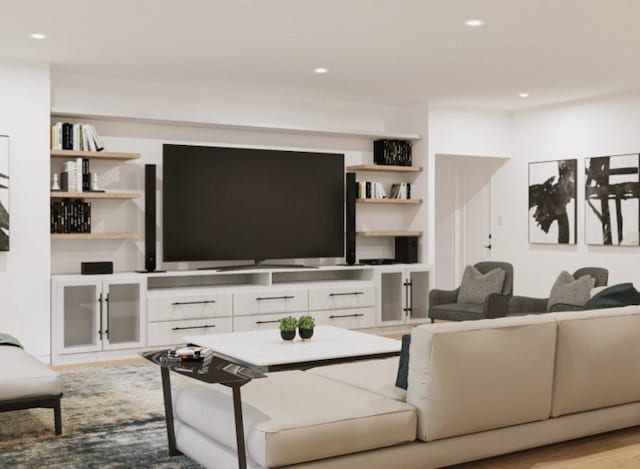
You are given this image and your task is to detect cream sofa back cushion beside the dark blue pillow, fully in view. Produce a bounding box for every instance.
[407,316,556,441]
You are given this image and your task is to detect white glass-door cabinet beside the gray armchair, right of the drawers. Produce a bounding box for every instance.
[376,264,431,326]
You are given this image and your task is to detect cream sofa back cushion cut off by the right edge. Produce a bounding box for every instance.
[548,306,640,417]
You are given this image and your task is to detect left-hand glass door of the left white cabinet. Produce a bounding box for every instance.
[58,284,102,353]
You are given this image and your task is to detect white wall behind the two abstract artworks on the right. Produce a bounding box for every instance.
[494,93,640,296]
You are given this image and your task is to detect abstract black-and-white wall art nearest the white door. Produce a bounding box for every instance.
[529,159,578,244]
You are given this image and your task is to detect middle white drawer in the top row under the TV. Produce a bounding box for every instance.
[233,288,309,316]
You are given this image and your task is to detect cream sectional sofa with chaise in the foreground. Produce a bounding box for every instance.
[169,306,640,469]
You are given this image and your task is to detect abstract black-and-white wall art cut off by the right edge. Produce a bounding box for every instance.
[584,154,640,246]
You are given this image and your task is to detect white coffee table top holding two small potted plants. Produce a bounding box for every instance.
[184,326,401,367]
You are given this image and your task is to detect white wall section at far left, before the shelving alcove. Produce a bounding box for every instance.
[0,59,50,361]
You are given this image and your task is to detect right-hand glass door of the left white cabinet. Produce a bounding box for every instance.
[102,280,144,350]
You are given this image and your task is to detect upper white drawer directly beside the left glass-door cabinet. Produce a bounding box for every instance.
[147,291,232,322]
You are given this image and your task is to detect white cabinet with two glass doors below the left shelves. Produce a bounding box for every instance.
[51,275,146,356]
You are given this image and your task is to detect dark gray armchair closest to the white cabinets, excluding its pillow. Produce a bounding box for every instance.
[429,262,513,322]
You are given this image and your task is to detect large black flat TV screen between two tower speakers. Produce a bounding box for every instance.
[162,144,344,262]
